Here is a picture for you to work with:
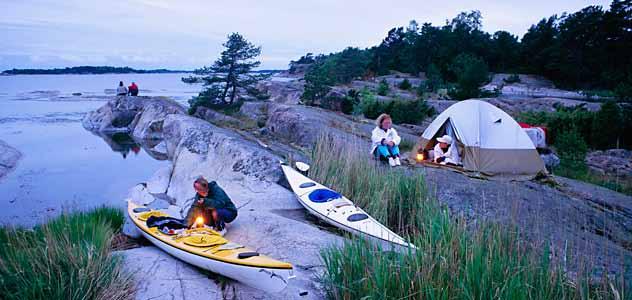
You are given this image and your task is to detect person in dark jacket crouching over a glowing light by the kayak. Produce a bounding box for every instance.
[185,177,237,235]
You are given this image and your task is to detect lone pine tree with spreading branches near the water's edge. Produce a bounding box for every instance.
[183,33,268,112]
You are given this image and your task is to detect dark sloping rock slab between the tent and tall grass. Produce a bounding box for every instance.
[417,164,632,279]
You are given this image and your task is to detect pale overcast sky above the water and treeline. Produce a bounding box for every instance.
[0,0,610,70]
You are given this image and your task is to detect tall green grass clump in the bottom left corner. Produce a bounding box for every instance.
[0,208,134,300]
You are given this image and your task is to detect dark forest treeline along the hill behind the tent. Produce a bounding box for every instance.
[298,0,632,97]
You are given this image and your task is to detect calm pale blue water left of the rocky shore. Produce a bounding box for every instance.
[0,74,200,226]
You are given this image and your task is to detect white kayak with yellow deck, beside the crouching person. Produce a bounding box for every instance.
[127,201,295,292]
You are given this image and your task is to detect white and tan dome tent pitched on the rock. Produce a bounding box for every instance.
[411,100,546,178]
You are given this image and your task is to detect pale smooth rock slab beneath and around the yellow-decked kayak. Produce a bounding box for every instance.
[88,97,342,299]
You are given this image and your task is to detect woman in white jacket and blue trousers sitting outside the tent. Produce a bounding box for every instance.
[371,114,402,167]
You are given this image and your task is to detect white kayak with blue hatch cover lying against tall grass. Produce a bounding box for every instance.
[281,163,416,249]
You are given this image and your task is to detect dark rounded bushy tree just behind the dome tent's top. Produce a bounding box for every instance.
[450,54,489,100]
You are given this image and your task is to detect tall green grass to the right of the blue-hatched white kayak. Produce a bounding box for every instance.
[310,137,625,299]
